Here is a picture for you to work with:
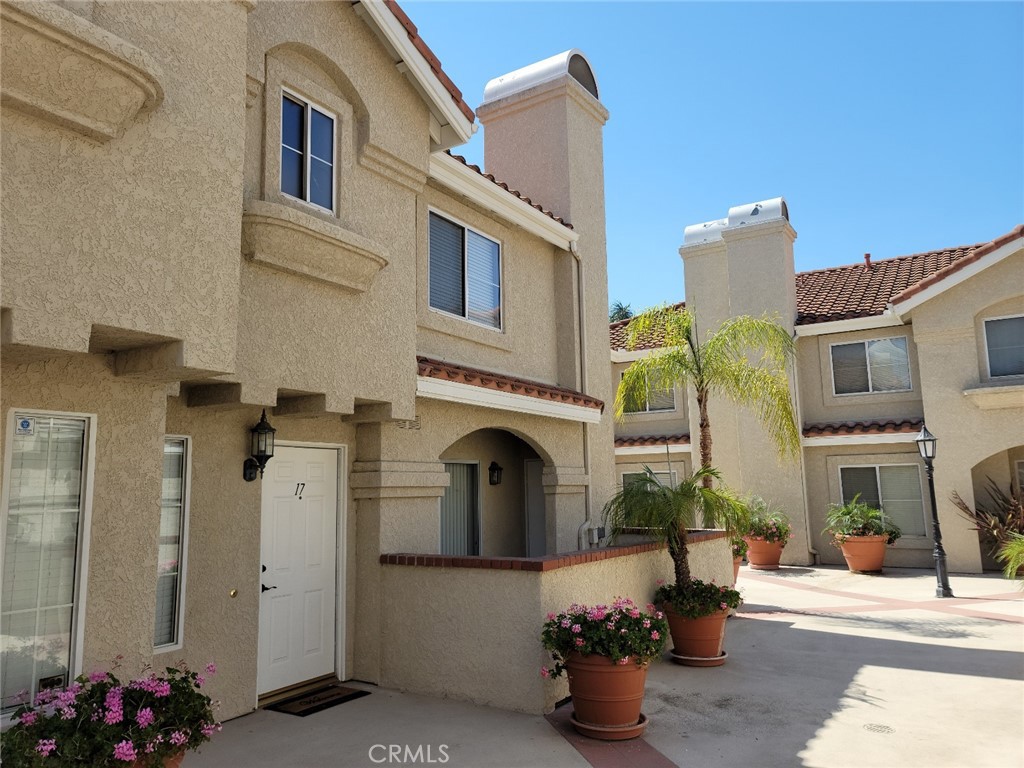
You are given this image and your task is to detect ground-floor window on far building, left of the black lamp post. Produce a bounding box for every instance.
[839,464,925,536]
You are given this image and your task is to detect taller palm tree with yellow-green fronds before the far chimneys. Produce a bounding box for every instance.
[615,306,800,486]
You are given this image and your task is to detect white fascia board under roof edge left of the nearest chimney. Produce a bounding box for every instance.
[429,153,580,251]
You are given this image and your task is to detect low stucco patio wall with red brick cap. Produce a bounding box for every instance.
[380,531,732,714]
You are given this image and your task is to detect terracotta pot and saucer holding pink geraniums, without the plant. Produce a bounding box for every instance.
[565,653,647,740]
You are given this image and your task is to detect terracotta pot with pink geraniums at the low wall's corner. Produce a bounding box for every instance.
[541,598,669,740]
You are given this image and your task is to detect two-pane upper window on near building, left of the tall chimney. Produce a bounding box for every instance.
[430,213,502,329]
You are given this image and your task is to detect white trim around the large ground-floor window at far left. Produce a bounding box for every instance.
[0,408,96,728]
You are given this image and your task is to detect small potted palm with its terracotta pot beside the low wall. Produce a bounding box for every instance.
[604,467,745,667]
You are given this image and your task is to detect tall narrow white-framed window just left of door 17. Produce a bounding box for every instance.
[153,437,188,647]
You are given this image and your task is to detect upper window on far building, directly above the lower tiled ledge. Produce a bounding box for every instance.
[831,336,910,394]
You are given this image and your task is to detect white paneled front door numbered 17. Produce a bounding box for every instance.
[257,445,338,694]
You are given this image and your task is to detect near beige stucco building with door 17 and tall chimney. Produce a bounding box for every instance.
[0,0,727,718]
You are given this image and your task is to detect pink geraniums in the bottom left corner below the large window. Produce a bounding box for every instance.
[3,663,220,768]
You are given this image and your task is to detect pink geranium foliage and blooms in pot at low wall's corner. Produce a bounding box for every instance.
[541,597,669,678]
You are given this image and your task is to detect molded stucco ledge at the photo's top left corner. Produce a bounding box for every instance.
[0,2,164,141]
